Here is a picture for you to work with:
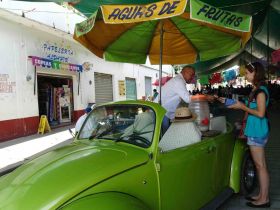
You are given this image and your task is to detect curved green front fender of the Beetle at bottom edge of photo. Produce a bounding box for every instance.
[59,192,150,210]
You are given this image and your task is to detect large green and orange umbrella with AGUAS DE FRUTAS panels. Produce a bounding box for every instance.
[74,0,251,101]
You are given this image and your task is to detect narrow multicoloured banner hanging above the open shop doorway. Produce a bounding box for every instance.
[29,56,83,72]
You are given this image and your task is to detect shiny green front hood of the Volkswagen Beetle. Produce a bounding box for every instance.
[0,141,148,210]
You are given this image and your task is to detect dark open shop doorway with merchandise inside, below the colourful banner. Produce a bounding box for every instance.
[37,74,74,127]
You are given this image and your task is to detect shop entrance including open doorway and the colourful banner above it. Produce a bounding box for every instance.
[29,56,84,127]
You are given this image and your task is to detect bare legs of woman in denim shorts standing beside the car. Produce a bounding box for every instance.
[250,146,269,205]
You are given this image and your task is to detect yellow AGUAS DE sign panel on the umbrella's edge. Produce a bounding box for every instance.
[101,0,187,24]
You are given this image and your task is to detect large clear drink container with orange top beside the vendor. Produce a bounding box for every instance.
[189,95,210,131]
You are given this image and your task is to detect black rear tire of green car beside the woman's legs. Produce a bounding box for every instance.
[240,152,257,195]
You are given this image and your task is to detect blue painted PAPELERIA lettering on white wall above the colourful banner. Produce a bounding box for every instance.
[42,41,75,63]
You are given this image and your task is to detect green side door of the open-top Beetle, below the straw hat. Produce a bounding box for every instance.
[157,140,216,210]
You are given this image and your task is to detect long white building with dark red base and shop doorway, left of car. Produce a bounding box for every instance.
[0,10,173,142]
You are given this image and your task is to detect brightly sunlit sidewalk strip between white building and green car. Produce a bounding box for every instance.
[0,125,74,176]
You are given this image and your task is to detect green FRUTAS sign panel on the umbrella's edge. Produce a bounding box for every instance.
[190,0,252,32]
